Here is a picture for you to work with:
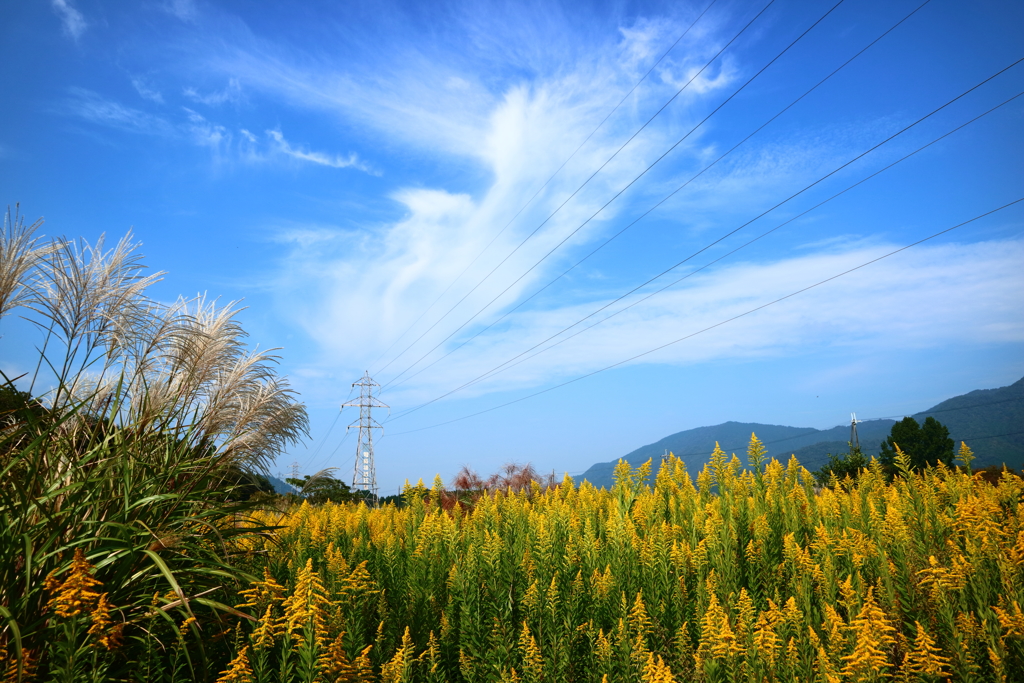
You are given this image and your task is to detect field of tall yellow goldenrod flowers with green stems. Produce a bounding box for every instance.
[211,437,1024,683]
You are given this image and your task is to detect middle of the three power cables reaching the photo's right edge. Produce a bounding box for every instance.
[392,91,1024,420]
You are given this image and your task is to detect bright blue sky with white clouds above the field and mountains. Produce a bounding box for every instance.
[0,0,1024,494]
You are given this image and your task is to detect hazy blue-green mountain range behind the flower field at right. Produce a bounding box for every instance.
[580,379,1024,486]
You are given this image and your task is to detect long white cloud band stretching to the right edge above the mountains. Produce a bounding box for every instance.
[378,239,1024,400]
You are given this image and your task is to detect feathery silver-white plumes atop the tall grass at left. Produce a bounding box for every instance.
[3,221,308,469]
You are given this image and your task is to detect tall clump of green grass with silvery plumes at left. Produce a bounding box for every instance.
[0,205,307,681]
